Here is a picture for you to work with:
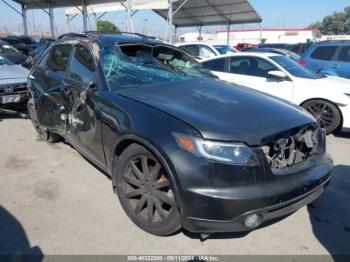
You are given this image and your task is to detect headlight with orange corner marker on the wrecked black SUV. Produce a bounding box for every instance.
[174,133,258,166]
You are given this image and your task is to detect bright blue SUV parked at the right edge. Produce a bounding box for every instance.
[299,41,350,78]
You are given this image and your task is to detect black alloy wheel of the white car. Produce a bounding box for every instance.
[303,99,341,134]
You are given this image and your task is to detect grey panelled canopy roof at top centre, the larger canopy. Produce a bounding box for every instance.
[154,0,262,27]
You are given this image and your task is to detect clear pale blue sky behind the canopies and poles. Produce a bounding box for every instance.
[0,0,350,36]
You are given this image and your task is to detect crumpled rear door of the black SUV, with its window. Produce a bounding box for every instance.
[29,44,72,136]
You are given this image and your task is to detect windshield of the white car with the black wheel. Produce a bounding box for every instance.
[271,56,321,79]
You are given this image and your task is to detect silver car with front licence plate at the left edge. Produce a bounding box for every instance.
[0,56,29,107]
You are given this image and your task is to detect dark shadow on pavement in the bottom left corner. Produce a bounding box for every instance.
[0,205,44,262]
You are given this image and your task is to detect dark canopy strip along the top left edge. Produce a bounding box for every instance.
[13,0,119,9]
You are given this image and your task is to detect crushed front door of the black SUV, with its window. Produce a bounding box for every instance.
[64,44,105,167]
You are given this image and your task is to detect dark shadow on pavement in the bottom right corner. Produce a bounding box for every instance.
[308,165,350,262]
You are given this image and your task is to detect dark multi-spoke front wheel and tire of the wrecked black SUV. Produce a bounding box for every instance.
[113,144,181,236]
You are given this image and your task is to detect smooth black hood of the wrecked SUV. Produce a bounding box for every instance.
[118,79,313,145]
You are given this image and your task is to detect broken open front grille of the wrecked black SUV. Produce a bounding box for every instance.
[261,125,325,173]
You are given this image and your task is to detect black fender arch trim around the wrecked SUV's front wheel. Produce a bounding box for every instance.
[111,134,183,214]
